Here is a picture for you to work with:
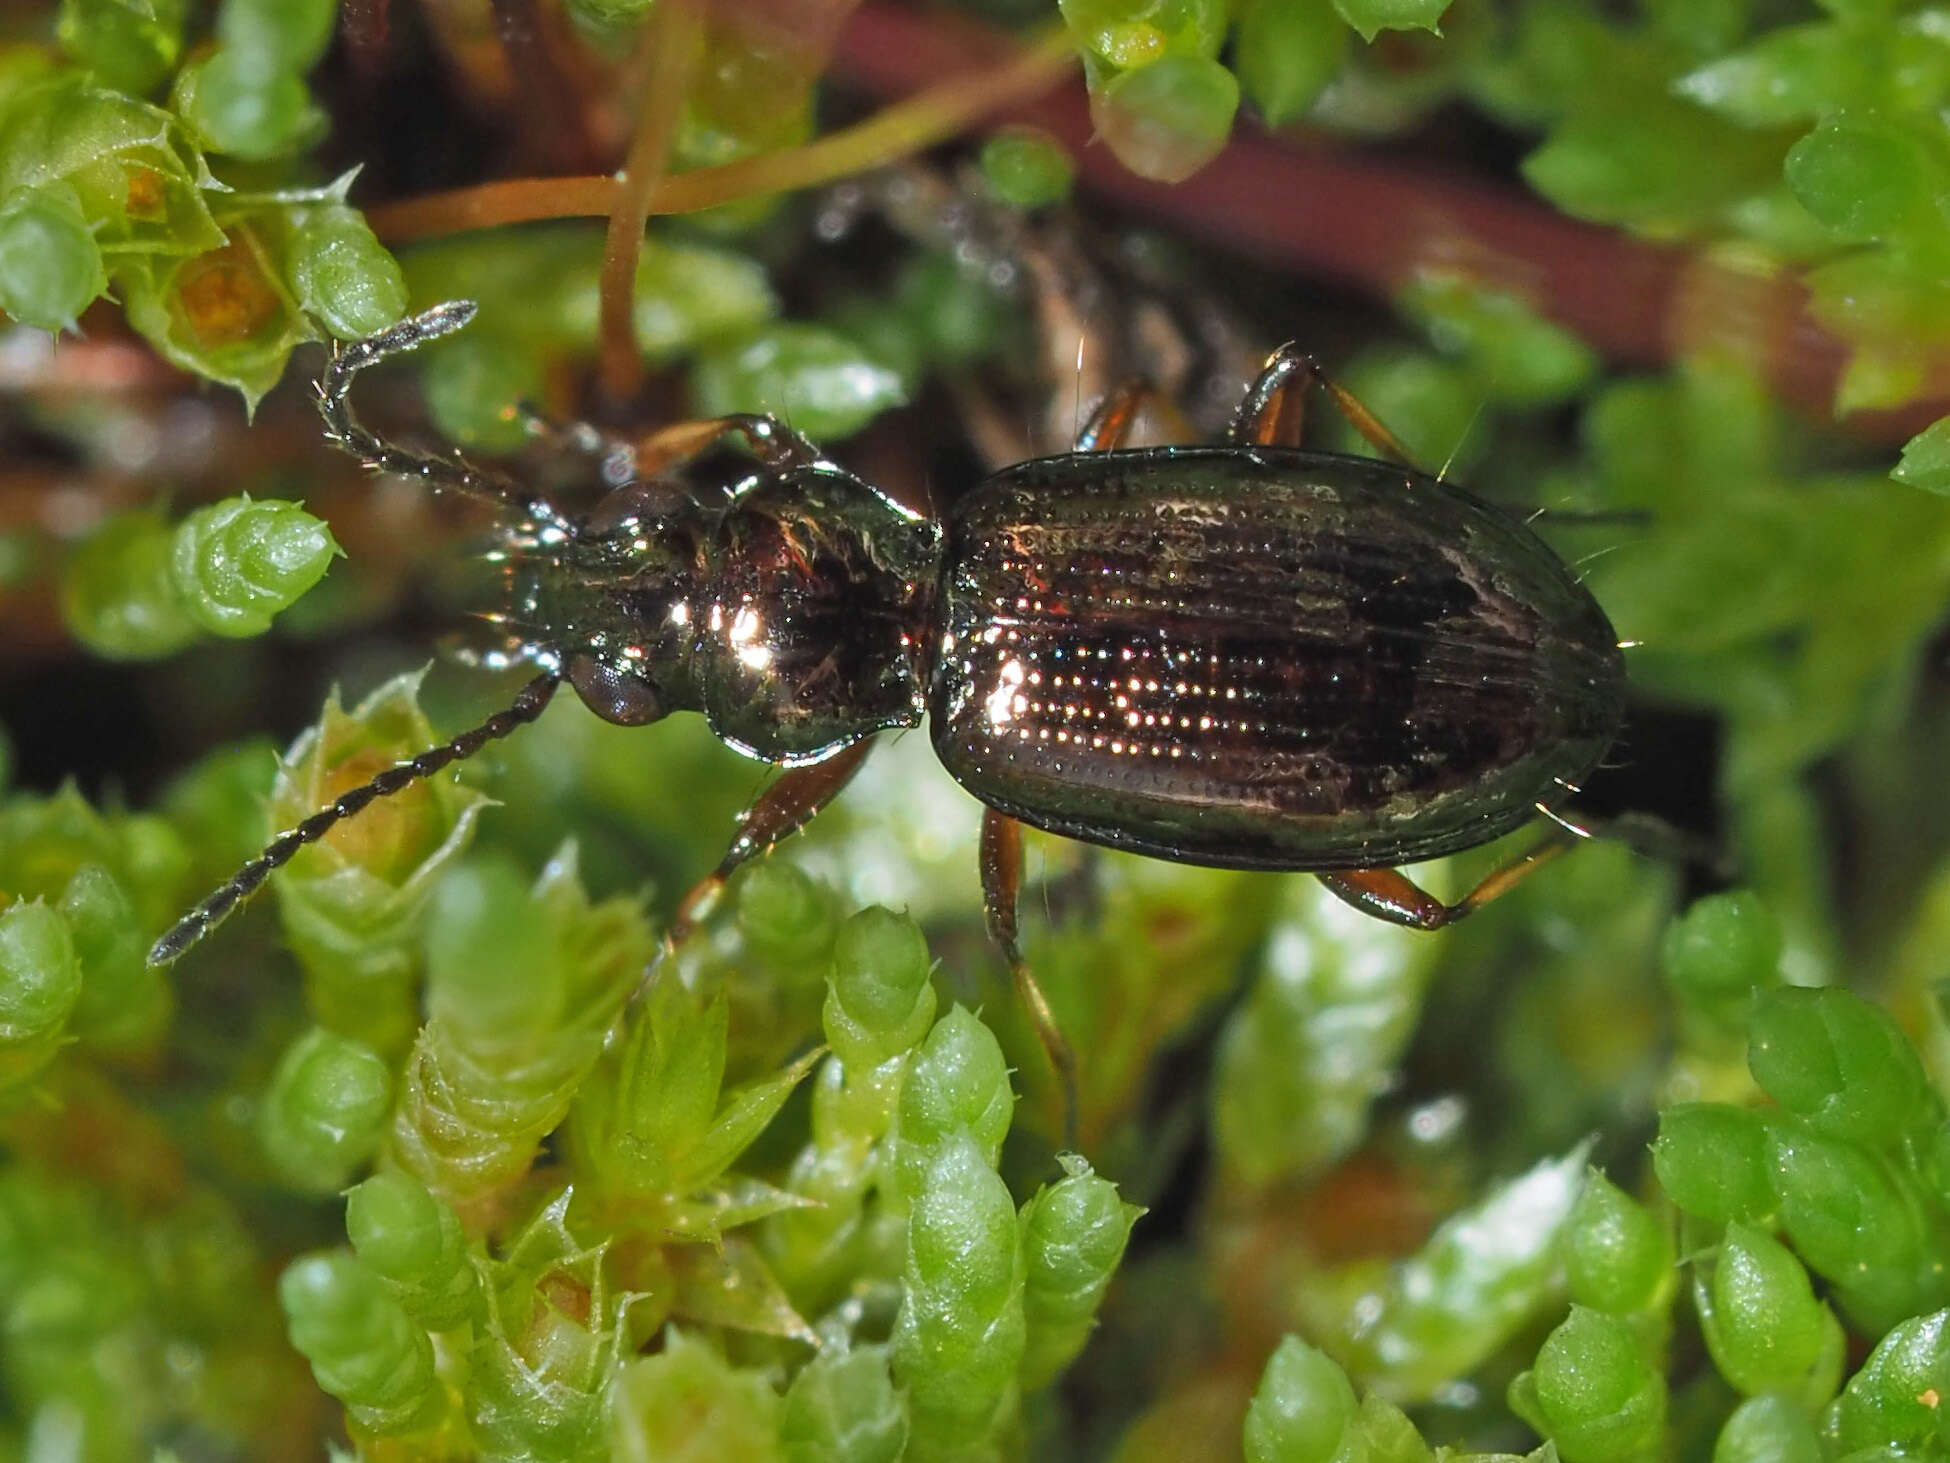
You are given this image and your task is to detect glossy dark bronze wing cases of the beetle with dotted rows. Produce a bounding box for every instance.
[928,447,1624,870]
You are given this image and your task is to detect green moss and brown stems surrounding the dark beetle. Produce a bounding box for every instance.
[0,0,1950,1463]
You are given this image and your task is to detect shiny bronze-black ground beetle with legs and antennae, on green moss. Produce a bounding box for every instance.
[150,302,1624,1110]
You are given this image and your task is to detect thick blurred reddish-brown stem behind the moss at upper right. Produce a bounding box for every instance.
[835,0,1950,441]
